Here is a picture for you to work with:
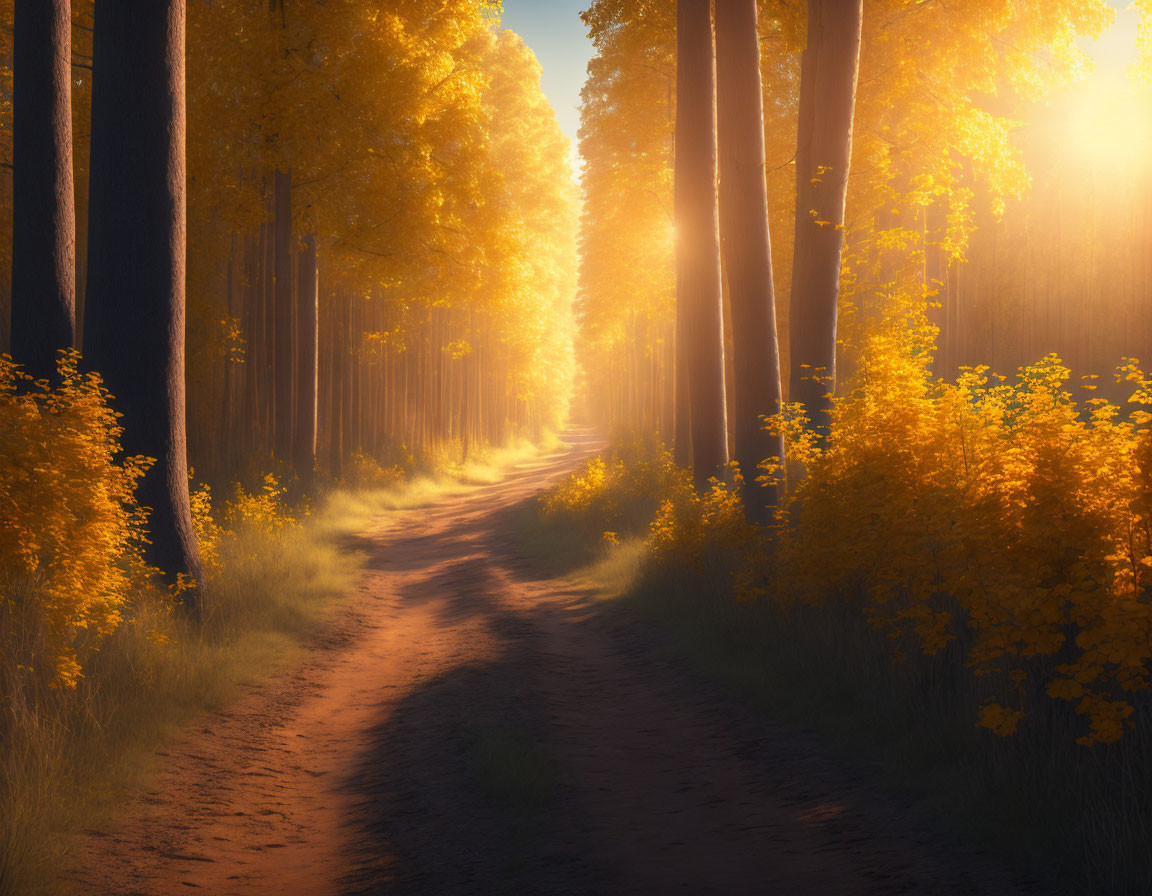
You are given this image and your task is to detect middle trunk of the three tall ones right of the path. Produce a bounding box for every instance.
[717,0,785,522]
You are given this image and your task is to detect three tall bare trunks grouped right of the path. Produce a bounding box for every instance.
[675,0,863,509]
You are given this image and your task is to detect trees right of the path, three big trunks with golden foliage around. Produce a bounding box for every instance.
[579,0,1111,509]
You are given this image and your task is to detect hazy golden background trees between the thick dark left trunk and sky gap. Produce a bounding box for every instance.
[190,6,585,479]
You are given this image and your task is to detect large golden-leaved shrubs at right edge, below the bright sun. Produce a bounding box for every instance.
[767,317,1152,745]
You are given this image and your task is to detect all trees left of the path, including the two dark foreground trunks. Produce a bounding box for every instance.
[0,0,576,598]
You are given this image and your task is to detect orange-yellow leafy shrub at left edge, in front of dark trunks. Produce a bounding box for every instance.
[0,352,151,686]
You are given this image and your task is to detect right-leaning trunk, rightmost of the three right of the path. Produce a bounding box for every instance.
[789,0,864,433]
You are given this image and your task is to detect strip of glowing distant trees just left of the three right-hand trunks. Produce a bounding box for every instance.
[579,2,677,446]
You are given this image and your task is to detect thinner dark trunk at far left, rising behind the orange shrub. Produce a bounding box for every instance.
[12,0,76,379]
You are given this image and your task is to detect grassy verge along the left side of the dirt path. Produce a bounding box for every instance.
[0,435,557,896]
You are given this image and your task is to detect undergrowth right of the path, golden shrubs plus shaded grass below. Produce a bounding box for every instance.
[536,332,1152,894]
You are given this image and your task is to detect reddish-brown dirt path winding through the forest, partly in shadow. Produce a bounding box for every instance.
[60,431,1030,896]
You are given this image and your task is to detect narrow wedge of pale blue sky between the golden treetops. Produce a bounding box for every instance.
[502,0,592,166]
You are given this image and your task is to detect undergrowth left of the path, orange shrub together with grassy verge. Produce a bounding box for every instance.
[0,354,550,896]
